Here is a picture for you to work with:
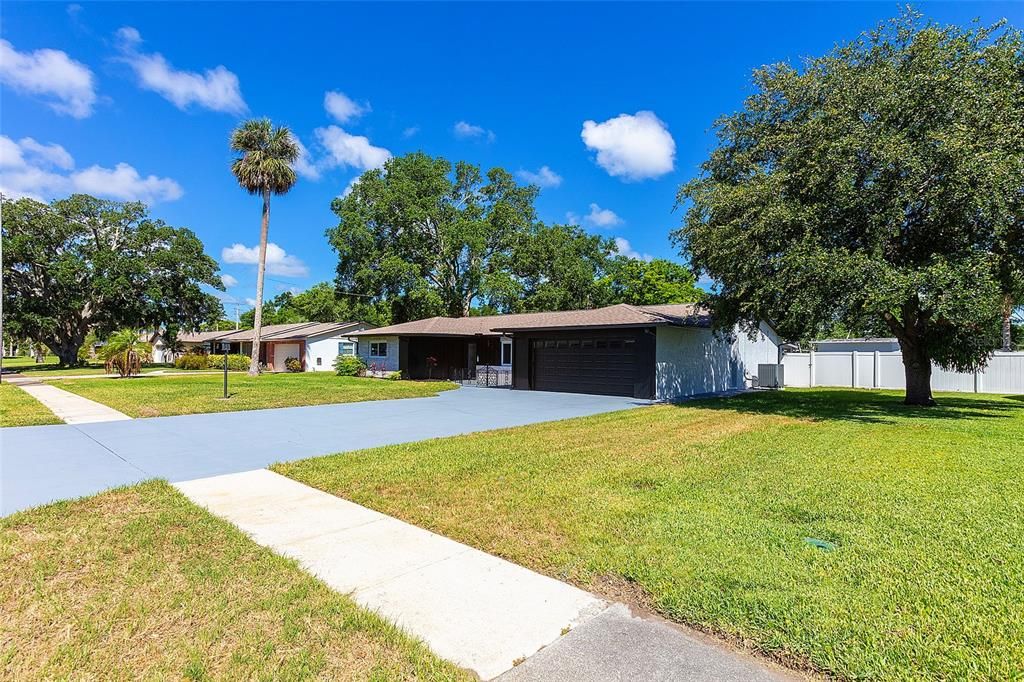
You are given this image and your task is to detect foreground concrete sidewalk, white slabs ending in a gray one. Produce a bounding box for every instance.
[176,470,792,682]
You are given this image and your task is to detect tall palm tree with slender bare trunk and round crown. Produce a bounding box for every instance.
[231,119,299,376]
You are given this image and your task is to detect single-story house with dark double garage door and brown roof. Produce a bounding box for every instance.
[352,304,779,399]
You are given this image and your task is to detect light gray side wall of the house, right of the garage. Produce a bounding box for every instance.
[654,325,779,400]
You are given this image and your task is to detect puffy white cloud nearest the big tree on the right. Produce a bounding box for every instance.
[581,112,676,180]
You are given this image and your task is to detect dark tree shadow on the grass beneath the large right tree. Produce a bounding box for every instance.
[678,388,1024,424]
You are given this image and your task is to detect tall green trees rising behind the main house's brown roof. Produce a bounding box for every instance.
[327,153,699,324]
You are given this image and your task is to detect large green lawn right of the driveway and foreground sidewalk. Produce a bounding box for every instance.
[273,389,1024,679]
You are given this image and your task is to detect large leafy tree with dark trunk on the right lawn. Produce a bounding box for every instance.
[673,11,1024,404]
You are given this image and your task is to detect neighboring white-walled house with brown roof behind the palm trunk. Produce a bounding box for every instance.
[178,323,371,372]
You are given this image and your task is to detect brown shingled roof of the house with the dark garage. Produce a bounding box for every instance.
[353,303,711,336]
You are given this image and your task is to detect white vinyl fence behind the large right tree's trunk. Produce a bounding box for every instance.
[782,351,1024,393]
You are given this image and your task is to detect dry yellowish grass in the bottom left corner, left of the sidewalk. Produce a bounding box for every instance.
[0,481,468,680]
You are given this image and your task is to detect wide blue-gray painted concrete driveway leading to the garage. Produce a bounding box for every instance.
[0,388,647,515]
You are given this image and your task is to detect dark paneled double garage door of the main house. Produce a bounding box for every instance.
[530,336,638,395]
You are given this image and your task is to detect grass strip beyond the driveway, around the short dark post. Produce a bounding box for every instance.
[48,372,455,417]
